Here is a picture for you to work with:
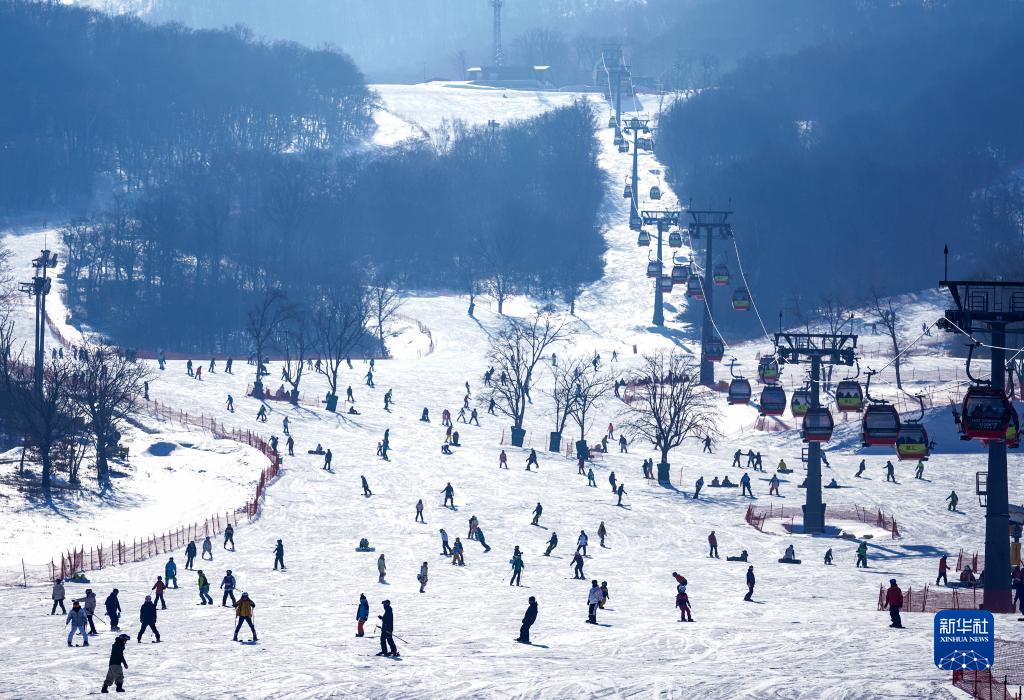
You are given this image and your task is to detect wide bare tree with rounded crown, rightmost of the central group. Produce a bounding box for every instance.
[620,352,721,480]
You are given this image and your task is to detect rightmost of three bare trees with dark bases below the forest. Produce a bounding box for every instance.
[314,285,371,410]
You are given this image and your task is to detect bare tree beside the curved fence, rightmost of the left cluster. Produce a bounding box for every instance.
[74,347,151,489]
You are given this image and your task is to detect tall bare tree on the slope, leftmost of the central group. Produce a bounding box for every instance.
[487,314,567,446]
